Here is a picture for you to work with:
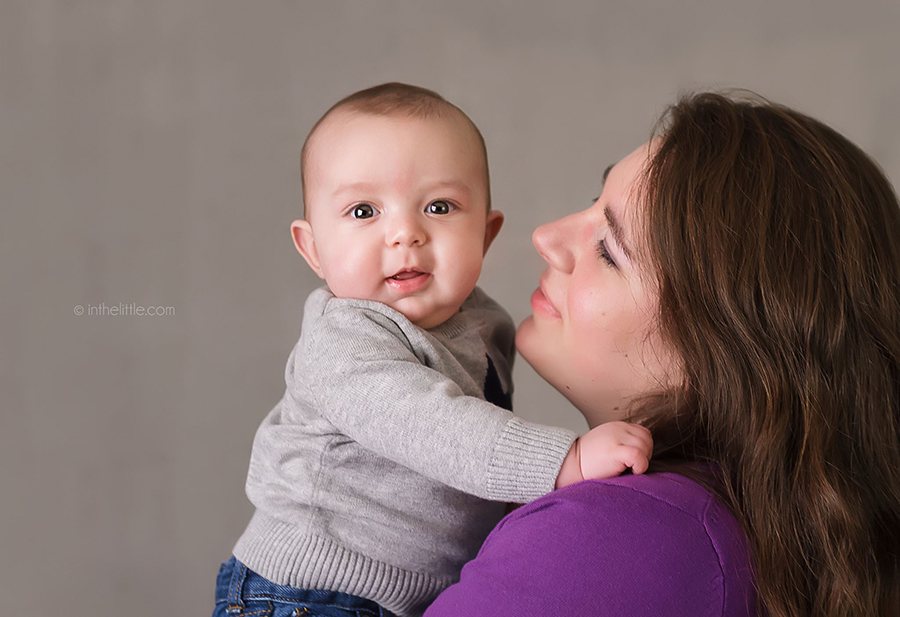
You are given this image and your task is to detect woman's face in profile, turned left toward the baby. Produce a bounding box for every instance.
[516,144,677,426]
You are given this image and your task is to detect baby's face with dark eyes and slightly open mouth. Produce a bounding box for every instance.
[295,111,503,328]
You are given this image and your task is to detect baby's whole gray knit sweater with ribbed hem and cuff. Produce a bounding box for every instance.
[234,288,576,615]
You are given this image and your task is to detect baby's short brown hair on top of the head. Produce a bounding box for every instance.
[300,82,491,216]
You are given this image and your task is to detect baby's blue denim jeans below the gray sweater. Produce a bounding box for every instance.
[213,557,394,617]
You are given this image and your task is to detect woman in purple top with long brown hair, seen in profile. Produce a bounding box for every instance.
[426,94,900,617]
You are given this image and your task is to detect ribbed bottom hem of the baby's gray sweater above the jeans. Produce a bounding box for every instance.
[234,510,457,617]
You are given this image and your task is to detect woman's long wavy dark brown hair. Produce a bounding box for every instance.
[642,93,900,617]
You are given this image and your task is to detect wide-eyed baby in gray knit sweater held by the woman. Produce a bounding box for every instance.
[220,84,651,615]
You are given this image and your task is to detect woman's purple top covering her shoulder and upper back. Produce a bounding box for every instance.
[425,473,756,617]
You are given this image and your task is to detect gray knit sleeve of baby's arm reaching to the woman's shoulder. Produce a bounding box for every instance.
[302,302,576,502]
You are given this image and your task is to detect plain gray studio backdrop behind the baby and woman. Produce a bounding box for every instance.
[0,0,900,617]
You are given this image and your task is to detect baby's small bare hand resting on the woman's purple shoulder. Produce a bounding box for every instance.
[556,422,653,488]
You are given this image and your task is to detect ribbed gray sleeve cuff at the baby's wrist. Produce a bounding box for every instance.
[487,418,578,503]
